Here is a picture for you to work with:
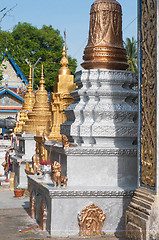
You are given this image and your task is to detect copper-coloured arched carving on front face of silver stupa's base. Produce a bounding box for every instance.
[78,204,106,236]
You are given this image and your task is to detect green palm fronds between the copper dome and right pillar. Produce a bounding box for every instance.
[124,37,138,77]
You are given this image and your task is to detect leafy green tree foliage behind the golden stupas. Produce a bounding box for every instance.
[0,23,77,91]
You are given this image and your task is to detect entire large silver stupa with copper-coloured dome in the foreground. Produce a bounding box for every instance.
[28,0,137,237]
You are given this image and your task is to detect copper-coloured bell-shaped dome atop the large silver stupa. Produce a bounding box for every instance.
[81,0,128,70]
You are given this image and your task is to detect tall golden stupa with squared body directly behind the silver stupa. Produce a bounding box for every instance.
[49,45,76,141]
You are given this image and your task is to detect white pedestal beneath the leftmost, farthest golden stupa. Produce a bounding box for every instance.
[11,133,35,188]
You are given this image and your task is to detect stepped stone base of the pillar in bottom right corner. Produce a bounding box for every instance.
[126,188,159,240]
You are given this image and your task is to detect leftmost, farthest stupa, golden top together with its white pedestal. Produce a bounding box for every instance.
[11,66,35,187]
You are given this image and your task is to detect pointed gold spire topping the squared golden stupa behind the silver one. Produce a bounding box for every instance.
[58,45,71,75]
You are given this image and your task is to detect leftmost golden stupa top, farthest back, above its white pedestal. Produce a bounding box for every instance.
[14,66,35,133]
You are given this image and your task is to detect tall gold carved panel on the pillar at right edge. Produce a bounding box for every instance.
[141,0,157,187]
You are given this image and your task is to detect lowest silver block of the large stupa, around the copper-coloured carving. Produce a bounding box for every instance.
[28,176,134,237]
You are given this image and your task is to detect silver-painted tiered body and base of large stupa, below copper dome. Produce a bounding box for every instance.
[29,70,137,237]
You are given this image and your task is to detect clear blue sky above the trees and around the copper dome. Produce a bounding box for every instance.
[0,0,137,70]
